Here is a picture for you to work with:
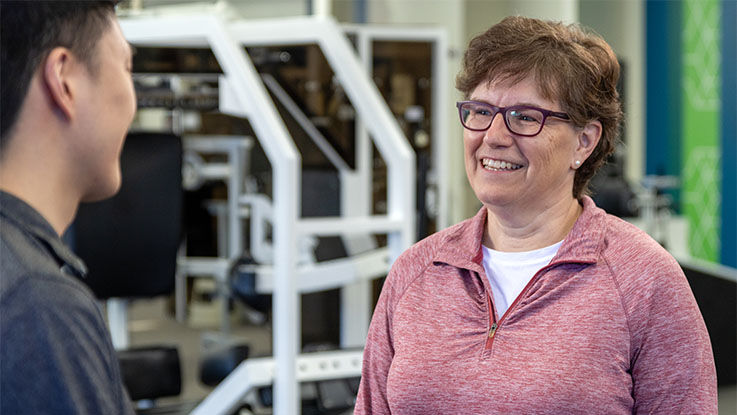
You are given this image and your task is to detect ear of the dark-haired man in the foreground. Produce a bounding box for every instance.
[41,47,76,119]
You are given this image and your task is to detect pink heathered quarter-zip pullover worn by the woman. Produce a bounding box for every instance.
[355,197,717,415]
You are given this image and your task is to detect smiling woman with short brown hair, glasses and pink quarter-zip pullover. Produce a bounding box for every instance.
[355,17,717,414]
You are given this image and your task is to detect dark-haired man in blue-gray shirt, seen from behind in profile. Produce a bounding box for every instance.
[0,0,136,414]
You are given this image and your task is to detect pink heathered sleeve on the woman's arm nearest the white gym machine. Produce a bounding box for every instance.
[354,257,401,415]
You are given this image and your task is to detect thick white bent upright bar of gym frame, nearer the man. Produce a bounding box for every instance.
[121,15,301,415]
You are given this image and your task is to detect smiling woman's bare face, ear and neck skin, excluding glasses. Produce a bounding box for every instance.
[464,74,601,251]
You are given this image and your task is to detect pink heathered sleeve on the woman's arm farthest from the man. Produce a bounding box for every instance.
[623,252,718,414]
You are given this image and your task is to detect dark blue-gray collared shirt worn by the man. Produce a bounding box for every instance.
[0,191,133,414]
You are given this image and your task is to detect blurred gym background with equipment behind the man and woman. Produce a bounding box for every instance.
[69,0,737,414]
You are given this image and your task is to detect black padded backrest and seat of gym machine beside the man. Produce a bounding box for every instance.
[73,133,182,410]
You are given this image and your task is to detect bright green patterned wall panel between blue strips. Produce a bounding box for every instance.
[681,0,721,262]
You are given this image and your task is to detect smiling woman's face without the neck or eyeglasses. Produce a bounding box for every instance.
[463,77,598,214]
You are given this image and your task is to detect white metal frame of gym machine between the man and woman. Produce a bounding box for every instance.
[121,14,415,415]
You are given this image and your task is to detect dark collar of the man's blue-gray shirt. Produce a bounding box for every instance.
[0,190,87,277]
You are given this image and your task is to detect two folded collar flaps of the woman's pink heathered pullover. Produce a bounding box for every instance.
[435,196,606,271]
